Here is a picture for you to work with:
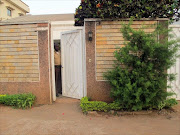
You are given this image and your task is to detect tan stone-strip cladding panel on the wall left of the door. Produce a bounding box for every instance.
[0,24,39,82]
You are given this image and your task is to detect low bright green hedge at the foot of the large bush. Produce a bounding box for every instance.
[80,97,121,113]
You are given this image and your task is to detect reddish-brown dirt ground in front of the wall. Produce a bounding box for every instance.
[0,98,180,135]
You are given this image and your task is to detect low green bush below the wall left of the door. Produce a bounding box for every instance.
[0,93,36,109]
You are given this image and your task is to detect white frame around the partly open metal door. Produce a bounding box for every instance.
[50,27,87,101]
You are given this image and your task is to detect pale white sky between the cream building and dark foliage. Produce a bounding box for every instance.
[22,0,81,15]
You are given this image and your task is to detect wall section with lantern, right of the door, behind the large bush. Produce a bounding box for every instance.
[85,19,167,102]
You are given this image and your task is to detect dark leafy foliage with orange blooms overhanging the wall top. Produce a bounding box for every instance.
[75,0,180,26]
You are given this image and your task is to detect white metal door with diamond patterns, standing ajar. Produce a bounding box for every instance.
[61,30,85,99]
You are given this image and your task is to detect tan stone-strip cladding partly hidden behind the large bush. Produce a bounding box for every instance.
[95,21,157,80]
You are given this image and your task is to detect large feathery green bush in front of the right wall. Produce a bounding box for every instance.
[105,20,179,111]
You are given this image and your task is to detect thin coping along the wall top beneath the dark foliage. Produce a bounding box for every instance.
[84,18,169,22]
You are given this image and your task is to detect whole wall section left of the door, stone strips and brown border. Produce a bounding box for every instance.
[0,22,52,104]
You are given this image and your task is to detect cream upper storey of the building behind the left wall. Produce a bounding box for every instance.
[0,0,30,21]
